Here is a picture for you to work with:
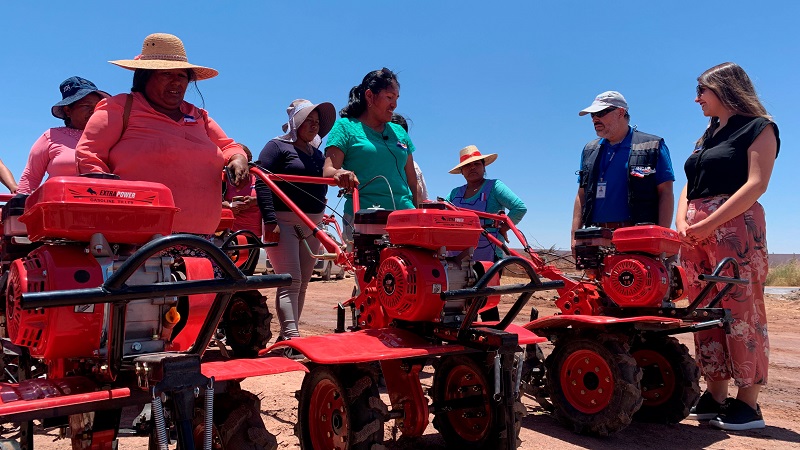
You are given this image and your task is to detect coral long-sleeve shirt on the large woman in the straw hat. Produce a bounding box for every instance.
[75,92,245,234]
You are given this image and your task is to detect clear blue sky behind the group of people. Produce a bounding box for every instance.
[0,0,800,253]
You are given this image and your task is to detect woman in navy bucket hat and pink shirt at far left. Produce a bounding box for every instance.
[17,77,109,194]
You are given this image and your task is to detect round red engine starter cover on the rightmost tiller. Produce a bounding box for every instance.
[602,255,670,307]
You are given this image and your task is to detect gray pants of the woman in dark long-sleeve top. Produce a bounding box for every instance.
[267,211,322,339]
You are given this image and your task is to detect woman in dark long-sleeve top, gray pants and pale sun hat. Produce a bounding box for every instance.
[256,99,336,340]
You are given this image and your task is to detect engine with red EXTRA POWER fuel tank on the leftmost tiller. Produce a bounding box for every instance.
[5,177,214,374]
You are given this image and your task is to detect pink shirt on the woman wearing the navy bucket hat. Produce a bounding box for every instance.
[17,127,83,194]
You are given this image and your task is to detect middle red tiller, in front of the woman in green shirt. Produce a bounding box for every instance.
[251,168,563,450]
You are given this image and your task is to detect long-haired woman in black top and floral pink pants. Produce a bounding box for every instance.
[676,63,780,430]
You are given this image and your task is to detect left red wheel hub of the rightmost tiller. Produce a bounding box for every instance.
[559,350,614,414]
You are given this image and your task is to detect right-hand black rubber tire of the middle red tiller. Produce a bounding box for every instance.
[431,355,526,450]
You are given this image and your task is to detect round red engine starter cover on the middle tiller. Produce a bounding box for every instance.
[376,246,447,322]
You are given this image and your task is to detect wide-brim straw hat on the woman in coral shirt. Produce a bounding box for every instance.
[109,33,219,80]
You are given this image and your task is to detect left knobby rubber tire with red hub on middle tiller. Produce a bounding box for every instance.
[295,364,386,450]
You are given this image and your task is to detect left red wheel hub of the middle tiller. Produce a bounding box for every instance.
[306,379,350,450]
